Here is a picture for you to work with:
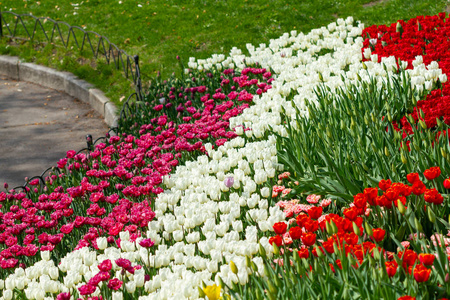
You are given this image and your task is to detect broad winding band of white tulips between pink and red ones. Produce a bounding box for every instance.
[0,18,446,299]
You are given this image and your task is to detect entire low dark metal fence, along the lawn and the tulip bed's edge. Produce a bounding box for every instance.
[0,11,144,191]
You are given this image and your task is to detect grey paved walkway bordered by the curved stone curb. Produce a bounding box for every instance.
[0,75,108,190]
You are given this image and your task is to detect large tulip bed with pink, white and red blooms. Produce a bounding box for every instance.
[0,12,450,299]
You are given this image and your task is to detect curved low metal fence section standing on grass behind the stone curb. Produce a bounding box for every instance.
[0,11,142,99]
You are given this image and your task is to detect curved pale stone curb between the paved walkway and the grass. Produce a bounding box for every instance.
[0,55,119,127]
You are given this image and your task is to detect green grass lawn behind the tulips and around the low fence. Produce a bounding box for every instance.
[0,0,448,105]
